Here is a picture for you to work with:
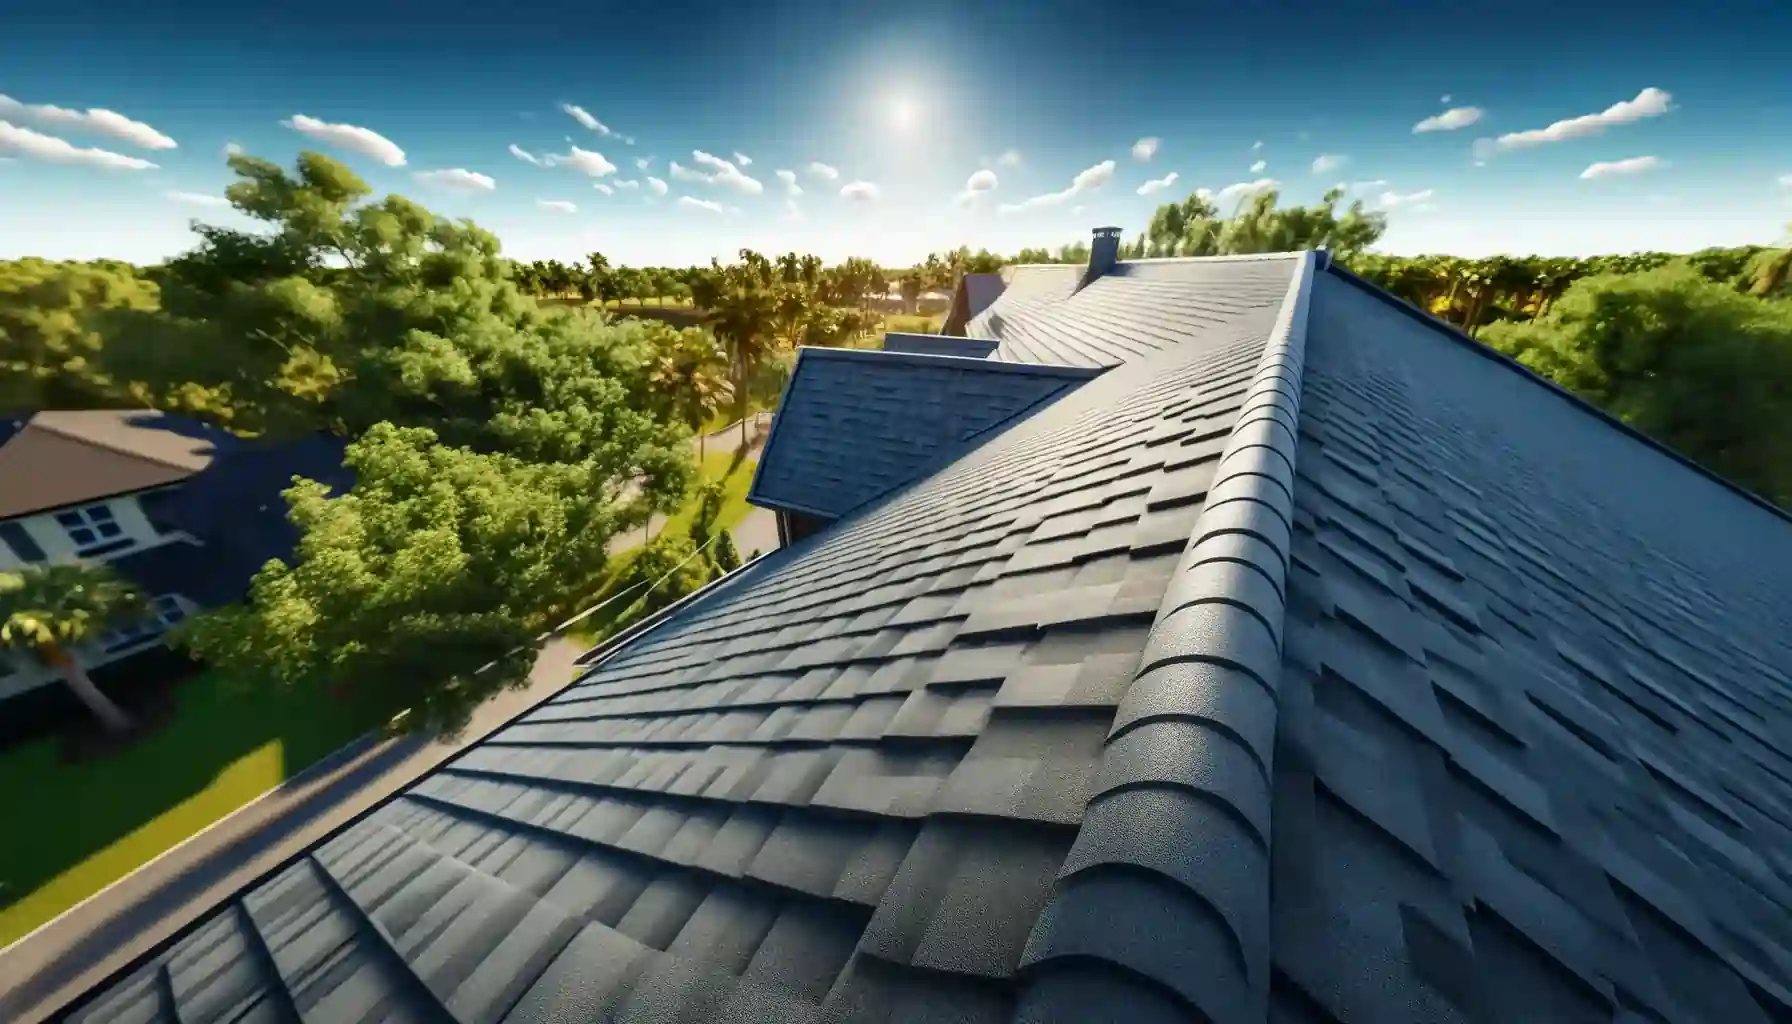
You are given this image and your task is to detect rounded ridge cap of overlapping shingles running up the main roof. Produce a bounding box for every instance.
[1016,253,1321,1024]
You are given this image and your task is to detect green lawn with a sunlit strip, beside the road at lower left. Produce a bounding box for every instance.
[0,671,369,947]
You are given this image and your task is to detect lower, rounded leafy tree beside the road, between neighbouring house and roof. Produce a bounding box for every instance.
[174,423,645,732]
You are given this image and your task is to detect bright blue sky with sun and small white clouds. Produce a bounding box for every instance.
[0,0,1792,264]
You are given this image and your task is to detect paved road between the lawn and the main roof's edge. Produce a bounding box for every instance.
[0,638,582,1024]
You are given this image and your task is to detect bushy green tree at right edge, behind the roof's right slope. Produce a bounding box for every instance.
[1484,264,1792,504]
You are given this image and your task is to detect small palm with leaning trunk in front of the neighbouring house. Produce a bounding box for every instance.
[0,565,145,733]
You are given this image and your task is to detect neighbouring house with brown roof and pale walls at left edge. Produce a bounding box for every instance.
[0,409,344,719]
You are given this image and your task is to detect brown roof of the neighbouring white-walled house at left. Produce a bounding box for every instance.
[0,409,235,518]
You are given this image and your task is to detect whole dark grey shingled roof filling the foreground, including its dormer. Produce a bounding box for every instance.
[56,237,1792,1024]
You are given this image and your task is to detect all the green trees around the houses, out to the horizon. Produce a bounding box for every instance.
[0,152,1792,730]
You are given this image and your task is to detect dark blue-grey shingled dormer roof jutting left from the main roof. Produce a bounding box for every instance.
[747,343,1098,518]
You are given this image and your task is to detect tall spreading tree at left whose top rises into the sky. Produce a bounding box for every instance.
[90,152,688,493]
